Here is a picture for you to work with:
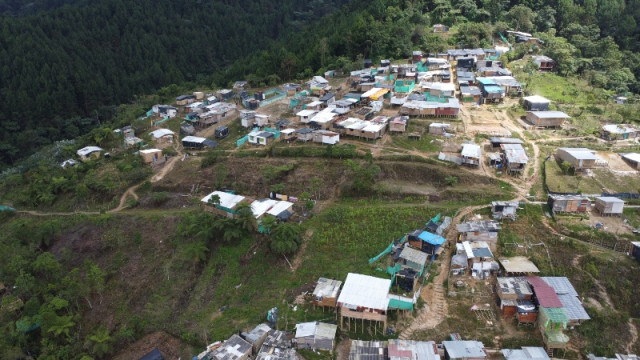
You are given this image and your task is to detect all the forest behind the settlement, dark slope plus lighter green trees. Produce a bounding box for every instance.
[0,0,640,166]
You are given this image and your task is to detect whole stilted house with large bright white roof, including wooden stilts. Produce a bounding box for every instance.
[338,273,391,331]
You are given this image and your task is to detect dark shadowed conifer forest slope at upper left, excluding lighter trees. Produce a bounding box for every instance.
[0,0,345,166]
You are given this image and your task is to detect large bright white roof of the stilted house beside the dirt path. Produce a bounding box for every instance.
[338,273,391,311]
